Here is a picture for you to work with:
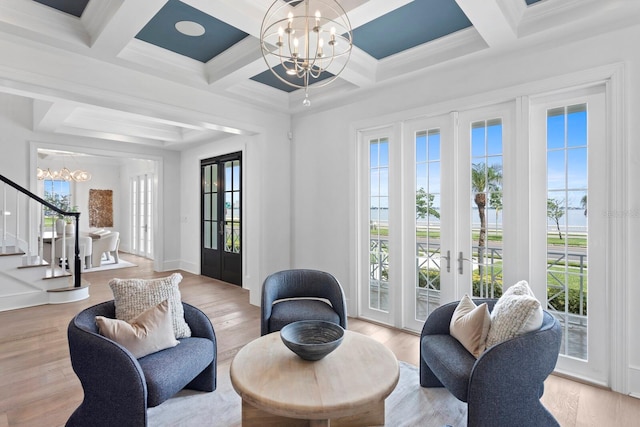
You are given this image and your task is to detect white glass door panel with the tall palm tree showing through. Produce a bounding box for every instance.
[455,103,516,299]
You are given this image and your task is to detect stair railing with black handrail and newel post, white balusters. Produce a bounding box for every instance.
[0,175,82,288]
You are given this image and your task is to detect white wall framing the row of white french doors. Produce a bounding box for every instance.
[291,26,640,394]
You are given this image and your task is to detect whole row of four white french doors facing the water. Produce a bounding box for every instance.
[358,89,607,383]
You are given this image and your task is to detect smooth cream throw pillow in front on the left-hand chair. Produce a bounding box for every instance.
[96,300,179,359]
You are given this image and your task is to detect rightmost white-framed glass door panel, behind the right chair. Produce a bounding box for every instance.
[532,87,609,385]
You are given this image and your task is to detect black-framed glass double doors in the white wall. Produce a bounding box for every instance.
[200,153,242,286]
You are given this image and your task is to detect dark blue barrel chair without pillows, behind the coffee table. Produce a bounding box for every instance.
[261,270,347,335]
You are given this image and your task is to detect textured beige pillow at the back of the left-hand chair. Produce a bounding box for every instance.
[109,273,191,338]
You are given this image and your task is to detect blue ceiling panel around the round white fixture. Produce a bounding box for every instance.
[136,0,248,62]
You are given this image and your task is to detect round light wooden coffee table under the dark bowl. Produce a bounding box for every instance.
[230,331,400,426]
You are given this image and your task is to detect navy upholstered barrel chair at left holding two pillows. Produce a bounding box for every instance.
[67,301,217,427]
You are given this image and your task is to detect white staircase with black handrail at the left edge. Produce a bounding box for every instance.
[0,175,89,311]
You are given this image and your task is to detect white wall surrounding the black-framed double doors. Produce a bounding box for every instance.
[180,115,291,305]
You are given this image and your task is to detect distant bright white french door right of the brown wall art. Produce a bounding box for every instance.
[129,174,153,259]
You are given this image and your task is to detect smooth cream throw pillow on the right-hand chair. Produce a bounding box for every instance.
[449,295,491,359]
